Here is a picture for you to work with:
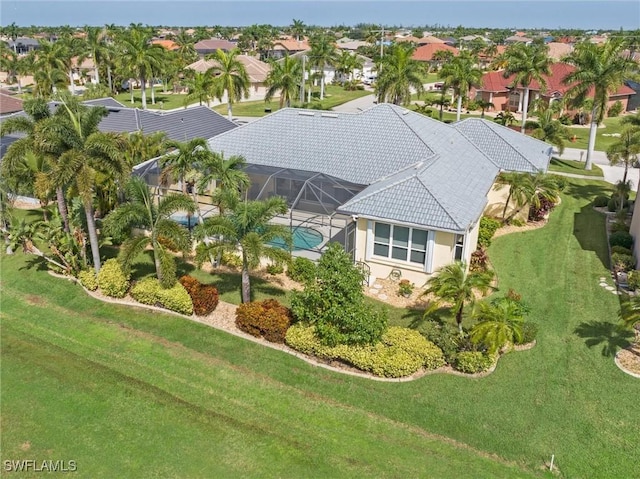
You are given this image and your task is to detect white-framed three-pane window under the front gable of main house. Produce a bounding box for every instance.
[373,222,428,265]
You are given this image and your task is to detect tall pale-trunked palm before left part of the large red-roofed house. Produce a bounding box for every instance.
[503,43,552,133]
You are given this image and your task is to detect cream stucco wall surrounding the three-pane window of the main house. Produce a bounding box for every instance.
[355,218,478,287]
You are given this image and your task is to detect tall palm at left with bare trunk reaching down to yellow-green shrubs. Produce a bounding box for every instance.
[43,97,129,273]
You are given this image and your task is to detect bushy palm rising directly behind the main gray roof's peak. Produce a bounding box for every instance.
[376,44,425,105]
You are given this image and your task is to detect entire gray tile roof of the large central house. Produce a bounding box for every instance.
[209,104,551,232]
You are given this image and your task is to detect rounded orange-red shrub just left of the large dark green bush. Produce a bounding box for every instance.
[236,299,291,343]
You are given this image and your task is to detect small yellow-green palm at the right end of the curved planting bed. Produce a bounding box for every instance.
[470,298,524,354]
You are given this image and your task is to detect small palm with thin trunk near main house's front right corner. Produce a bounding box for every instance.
[425,261,494,334]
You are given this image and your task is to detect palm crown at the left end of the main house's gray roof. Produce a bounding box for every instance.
[160,138,211,194]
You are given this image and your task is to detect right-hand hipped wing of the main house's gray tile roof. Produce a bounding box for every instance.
[453,118,552,173]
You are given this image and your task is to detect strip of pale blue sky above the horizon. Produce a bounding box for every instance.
[0,0,640,30]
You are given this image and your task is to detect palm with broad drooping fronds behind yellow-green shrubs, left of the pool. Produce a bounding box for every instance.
[104,176,196,288]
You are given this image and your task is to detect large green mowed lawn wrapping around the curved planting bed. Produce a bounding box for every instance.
[1,180,640,479]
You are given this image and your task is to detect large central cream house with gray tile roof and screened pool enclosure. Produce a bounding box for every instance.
[146,104,552,285]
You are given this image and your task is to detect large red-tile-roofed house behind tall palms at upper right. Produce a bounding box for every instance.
[469,63,635,112]
